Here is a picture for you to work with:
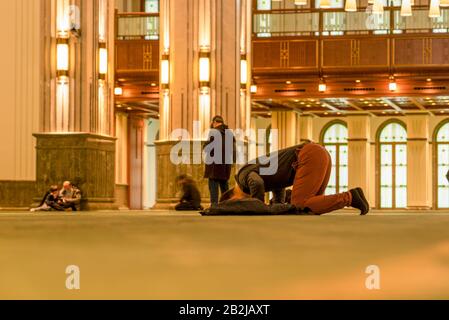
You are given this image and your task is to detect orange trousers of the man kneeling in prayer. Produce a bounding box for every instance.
[292,143,352,215]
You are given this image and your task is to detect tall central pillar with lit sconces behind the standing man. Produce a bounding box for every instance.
[156,0,251,207]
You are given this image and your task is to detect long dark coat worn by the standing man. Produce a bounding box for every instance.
[204,125,235,181]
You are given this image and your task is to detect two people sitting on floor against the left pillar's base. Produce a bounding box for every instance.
[31,181,81,212]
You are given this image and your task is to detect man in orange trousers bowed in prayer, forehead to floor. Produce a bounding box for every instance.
[220,142,370,215]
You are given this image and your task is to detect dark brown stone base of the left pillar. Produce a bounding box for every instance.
[34,133,118,211]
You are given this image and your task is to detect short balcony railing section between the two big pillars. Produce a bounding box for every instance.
[116,13,159,40]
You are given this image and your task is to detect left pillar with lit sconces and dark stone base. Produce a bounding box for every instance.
[35,0,115,210]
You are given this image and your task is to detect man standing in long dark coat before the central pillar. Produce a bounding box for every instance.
[204,116,235,206]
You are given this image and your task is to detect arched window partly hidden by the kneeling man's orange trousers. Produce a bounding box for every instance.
[322,122,349,194]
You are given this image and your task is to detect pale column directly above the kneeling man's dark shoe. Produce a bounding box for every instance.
[347,115,375,207]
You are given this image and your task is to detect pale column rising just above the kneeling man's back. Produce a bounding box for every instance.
[271,111,301,151]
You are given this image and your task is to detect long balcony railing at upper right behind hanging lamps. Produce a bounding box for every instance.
[253,7,449,38]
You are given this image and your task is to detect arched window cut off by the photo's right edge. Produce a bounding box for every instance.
[436,122,449,209]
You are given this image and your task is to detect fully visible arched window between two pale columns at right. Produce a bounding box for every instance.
[379,122,407,209]
